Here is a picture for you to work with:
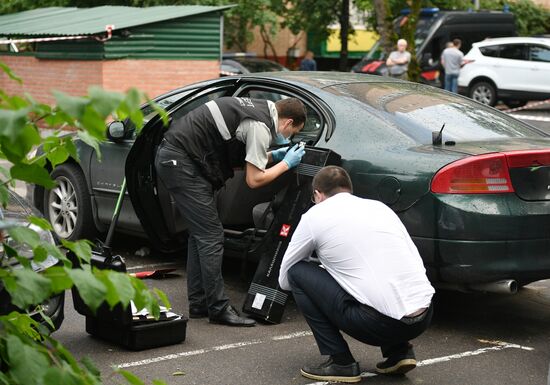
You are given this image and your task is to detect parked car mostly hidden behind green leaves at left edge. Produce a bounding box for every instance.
[0,191,65,330]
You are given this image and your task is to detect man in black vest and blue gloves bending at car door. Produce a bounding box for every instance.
[155,97,306,326]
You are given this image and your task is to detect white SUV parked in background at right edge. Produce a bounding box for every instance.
[458,37,550,108]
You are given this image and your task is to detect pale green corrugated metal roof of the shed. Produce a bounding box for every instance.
[0,5,233,37]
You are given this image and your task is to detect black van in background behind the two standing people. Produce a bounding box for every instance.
[352,8,516,87]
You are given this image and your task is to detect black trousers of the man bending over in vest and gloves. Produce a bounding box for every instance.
[155,141,229,316]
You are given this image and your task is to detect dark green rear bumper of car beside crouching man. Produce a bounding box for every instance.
[413,237,550,285]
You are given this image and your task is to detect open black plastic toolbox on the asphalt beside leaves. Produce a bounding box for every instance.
[72,247,187,350]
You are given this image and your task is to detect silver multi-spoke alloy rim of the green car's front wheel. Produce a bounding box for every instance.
[48,176,78,239]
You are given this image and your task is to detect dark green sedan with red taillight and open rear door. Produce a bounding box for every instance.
[34,72,550,292]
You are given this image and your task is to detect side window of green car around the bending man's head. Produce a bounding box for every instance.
[238,89,323,145]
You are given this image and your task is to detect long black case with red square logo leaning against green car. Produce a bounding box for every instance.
[243,147,341,324]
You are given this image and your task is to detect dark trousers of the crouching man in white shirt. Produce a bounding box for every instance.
[289,262,433,357]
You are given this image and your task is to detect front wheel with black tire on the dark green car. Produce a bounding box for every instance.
[44,163,97,241]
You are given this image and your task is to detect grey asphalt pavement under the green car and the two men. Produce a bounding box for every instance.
[55,237,550,385]
